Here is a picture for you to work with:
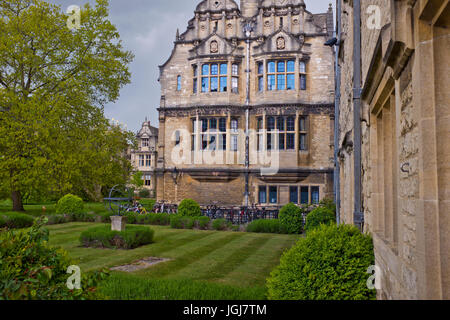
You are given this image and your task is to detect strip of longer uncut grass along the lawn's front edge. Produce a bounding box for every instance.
[100,274,265,300]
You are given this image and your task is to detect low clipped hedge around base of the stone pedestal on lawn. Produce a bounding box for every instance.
[80,225,154,249]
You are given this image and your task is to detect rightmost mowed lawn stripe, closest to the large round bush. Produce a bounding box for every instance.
[224,235,300,287]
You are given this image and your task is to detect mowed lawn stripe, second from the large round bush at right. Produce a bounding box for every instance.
[174,234,270,281]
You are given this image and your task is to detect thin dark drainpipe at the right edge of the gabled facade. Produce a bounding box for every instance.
[334,0,341,225]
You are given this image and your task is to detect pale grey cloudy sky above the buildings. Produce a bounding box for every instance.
[47,0,335,131]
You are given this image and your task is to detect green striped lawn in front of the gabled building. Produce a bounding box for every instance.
[45,223,299,299]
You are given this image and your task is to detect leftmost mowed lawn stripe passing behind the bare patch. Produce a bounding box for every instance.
[71,232,217,271]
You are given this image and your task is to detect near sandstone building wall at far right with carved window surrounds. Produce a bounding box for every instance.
[338,0,450,299]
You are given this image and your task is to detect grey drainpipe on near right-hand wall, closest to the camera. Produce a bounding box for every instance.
[353,0,364,231]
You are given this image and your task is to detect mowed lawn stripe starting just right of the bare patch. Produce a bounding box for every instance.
[138,232,244,278]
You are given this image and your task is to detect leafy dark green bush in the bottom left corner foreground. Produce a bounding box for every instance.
[0,218,107,300]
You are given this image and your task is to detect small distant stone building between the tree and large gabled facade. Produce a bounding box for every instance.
[130,119,158,197]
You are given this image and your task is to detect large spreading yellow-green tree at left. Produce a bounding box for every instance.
[0,0,133,211]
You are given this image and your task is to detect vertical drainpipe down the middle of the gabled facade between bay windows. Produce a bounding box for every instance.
[244,22,253,207]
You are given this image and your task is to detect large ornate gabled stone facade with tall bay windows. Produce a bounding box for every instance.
[157,0,334,206]
